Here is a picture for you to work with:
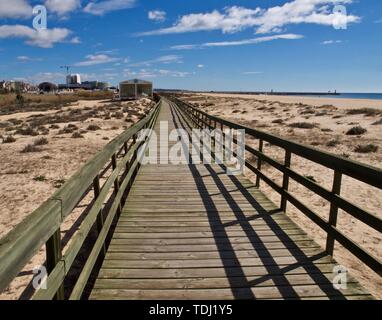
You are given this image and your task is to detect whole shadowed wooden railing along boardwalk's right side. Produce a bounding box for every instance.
[169,97,382,276]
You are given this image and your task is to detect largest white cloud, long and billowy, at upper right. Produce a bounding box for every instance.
[140,0,360,36]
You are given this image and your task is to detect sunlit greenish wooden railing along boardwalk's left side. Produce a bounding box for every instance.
[0,102,161,300]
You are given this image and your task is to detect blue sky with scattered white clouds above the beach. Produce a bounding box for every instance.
[0,0,382,92]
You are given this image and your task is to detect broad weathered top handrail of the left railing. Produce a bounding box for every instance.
[0,102,161,292]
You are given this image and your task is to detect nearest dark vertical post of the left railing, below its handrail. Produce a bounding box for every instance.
[45,229,65,300]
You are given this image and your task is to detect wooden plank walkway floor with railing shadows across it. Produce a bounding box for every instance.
[90,102,372,299]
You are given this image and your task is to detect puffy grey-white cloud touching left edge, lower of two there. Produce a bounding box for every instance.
[0,25,71,48]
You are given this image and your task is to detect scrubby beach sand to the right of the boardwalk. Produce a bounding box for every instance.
[181,93,382,299]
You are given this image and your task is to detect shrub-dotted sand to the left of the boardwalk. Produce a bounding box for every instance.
[0,99,154,300]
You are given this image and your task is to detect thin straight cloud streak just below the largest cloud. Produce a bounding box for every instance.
[171,33,304,50]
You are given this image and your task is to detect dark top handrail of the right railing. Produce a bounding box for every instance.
[175,98,382,189]
